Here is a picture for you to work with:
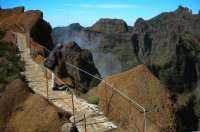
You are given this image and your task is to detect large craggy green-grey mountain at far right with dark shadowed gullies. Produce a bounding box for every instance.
[132,6,200,92]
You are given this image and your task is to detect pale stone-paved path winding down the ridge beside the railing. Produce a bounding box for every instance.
[16,33,117,132]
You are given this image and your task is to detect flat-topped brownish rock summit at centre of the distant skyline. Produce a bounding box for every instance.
[90,18,128,34]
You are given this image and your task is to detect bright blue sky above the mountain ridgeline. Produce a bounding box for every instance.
[0,0,200,27]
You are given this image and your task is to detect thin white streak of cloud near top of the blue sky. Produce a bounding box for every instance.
[79,4,136,9]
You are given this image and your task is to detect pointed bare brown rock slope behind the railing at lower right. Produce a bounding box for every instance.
[98,65,176,131]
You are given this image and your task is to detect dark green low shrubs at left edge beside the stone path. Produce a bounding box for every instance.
[0,30,24,92]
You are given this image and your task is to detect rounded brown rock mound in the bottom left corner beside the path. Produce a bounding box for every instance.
[0,80,66,132]
